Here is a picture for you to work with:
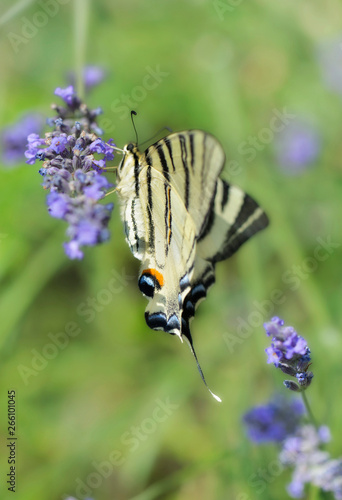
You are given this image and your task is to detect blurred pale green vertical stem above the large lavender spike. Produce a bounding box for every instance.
[74,0,90,100]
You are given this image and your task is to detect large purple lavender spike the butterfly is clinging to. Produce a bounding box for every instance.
[25,86,114,259]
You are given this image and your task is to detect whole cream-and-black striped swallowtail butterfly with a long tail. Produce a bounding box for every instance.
[116,130,268,401]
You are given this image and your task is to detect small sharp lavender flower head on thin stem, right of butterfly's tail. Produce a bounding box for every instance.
[264,317,313,391]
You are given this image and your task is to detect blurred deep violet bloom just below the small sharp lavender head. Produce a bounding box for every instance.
[243,397,304,443]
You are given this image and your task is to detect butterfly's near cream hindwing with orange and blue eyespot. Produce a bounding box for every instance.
[135,165,196,337]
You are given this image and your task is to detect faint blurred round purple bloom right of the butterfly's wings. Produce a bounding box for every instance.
[274,120,321,174]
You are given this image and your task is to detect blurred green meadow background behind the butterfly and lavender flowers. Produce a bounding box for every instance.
[0,0,342,500]
